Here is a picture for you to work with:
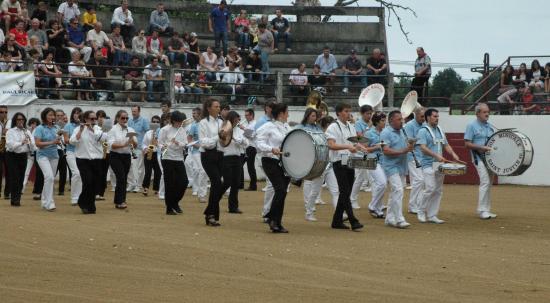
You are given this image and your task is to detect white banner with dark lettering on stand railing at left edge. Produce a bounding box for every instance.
[0,71,37,106]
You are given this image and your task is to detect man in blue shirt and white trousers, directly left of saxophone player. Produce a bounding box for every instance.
[126,106,149,193]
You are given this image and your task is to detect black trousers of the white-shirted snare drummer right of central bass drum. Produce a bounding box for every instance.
[332,161,357,224]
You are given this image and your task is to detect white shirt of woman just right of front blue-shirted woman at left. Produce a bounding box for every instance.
[69,125,107,160]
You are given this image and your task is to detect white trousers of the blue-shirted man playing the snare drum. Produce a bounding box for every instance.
[424,163,445,218]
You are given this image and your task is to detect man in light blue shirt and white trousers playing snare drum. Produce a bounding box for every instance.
[416,108,460,224]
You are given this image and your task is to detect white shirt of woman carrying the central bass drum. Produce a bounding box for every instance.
[256,121,291,160]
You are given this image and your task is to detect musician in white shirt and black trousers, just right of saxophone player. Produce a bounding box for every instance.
[158,110,189,215]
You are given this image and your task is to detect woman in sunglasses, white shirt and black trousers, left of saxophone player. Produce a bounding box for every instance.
[107,110,137,209]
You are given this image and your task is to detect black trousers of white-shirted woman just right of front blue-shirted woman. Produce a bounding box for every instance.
[76,158,103,211]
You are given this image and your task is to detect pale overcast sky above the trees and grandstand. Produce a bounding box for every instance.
[228,0,550,79]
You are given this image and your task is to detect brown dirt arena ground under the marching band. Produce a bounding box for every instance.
[0,185,550,302]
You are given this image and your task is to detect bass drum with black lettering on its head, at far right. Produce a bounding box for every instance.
[484,129,534,176]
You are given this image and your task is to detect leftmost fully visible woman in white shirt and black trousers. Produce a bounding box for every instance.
[6,113,35,206]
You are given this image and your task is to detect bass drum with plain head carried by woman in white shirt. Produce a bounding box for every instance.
[281,129,329,180]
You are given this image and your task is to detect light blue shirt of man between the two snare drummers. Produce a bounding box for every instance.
[380,126,407,177]
